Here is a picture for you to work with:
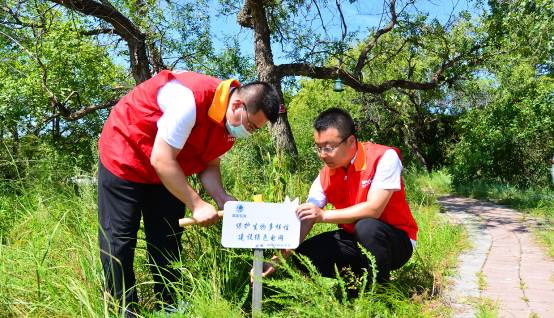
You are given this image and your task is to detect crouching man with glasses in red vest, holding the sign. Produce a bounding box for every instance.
[264,108,418,283]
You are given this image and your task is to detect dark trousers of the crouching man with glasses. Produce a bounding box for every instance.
[296,218,413,283]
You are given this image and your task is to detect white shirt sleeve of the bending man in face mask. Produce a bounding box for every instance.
[157,80,196,149]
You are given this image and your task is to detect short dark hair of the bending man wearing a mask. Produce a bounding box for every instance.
[237,81,281,124]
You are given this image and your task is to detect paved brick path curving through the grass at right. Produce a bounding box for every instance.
[439,196,554,318]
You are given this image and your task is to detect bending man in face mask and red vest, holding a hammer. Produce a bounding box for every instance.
[98,71,280,314]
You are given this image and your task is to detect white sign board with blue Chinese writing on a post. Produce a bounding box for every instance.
[221,201,300,249]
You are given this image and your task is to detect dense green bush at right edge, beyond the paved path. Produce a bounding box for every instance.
[451,71,554,186]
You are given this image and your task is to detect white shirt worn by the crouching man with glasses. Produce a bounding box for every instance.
[307,149,402,208]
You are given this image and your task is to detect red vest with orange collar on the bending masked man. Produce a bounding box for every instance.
[98,71,239,183]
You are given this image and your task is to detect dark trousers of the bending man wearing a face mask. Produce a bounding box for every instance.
[98,163,185,306]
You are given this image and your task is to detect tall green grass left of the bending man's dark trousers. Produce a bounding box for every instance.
[0,153,107,317]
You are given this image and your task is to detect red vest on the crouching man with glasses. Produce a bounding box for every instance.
[319,142,417,240]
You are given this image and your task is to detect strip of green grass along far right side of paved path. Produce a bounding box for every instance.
[456,182,554,257]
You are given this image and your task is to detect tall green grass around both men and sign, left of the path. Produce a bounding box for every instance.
[0,153,466,317]
